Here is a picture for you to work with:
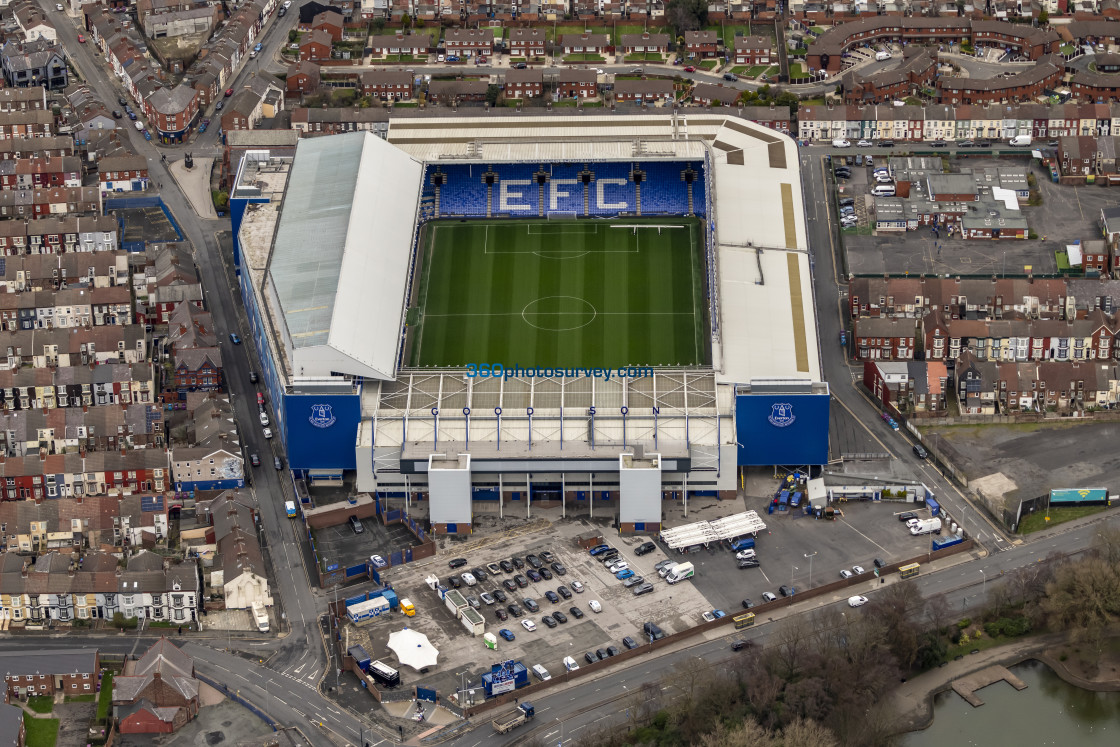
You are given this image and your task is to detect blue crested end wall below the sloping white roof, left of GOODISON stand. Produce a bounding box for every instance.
[277,394,362,471]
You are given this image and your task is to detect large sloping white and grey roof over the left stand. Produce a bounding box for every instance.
[268,132,423,380]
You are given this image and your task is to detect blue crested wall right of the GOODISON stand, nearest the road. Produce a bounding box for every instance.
[735,393,829,467]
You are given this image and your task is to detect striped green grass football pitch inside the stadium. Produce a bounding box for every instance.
[409,217,710,368]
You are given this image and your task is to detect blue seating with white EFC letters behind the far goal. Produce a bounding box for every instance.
[420,161,707,220]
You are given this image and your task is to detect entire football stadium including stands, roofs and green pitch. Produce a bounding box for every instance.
[231,112,829,533]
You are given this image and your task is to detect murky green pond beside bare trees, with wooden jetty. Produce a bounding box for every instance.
[902,661,1120,747]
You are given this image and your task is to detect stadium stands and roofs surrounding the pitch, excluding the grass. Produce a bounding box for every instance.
[231,113,829,533]
